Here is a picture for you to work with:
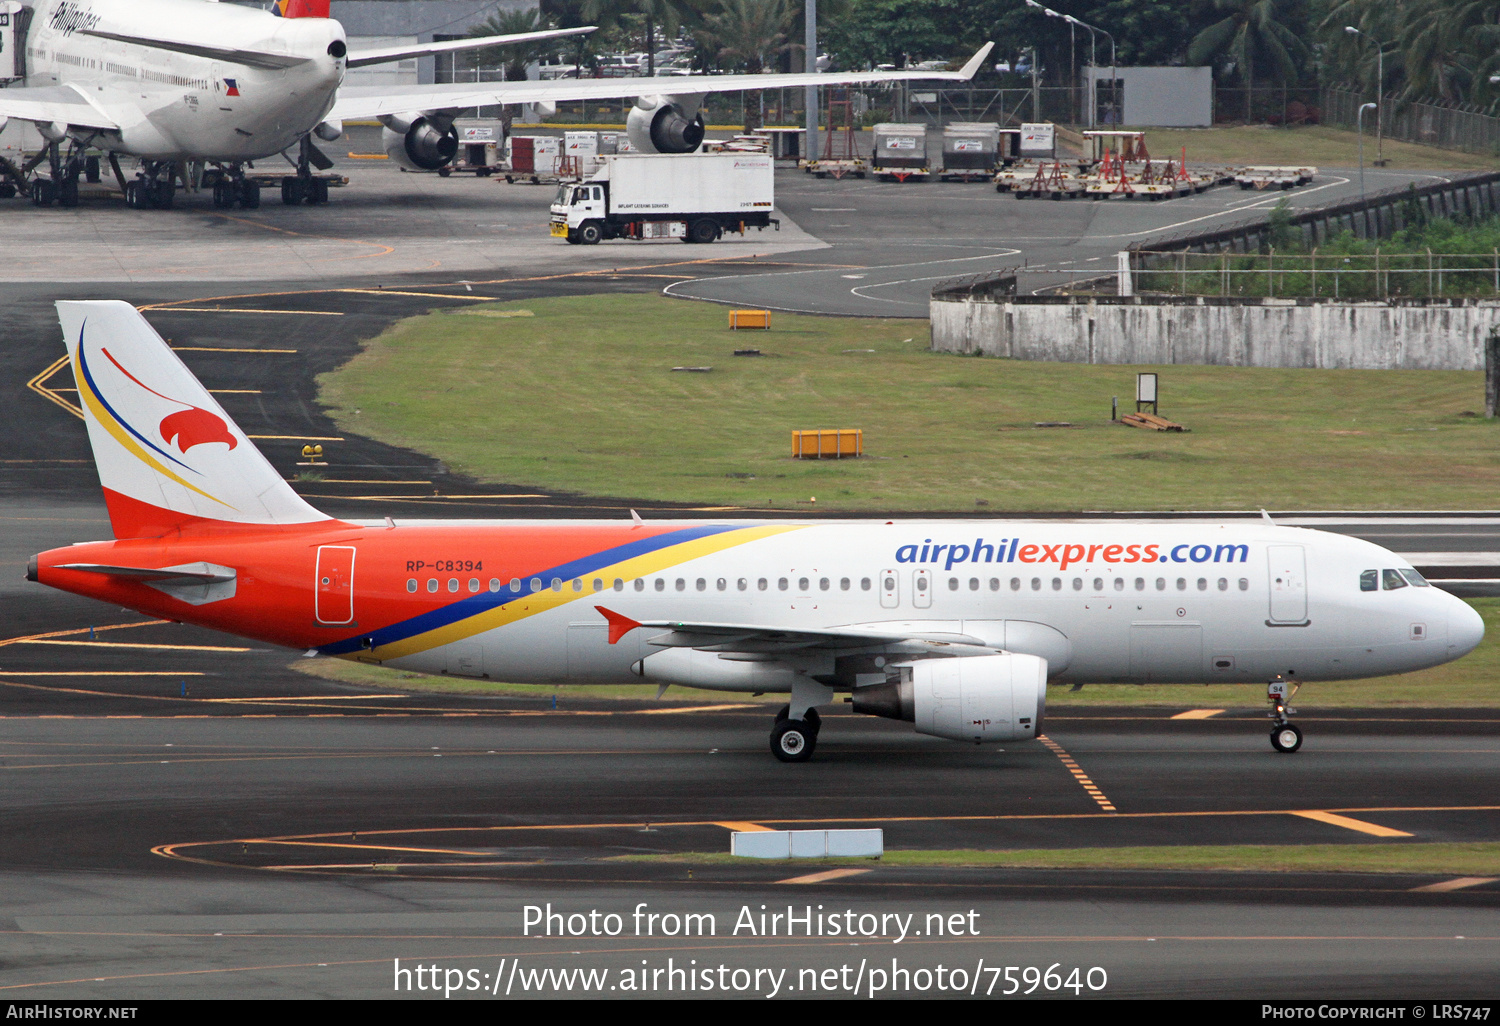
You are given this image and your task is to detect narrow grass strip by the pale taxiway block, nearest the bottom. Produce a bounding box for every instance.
[611,842,1500,876]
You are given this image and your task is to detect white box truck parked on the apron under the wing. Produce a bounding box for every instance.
[552,153,782,246]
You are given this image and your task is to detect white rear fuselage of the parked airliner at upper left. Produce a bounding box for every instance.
[26,0,344,162]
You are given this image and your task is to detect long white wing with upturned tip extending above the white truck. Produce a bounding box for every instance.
[329,42,995,122]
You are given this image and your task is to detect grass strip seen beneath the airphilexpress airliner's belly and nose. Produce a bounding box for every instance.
[293,599,1500,714]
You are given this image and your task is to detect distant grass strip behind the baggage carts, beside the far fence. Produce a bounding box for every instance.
[1142,125,1500,171]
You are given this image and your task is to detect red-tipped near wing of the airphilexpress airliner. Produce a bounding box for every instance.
[594,606,989,654]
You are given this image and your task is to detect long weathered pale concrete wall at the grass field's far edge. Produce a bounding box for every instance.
[932,297,1500,371]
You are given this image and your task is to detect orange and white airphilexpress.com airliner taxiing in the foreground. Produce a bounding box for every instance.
[27,300,1484,762]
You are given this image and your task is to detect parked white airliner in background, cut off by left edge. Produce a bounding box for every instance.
[0,0,993,207]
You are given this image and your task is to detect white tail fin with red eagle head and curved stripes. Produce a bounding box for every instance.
[57,300,332,539]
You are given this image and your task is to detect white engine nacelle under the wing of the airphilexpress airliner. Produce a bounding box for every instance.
[854,653,1047,744]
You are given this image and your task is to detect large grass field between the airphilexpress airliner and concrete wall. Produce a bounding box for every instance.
[320,294,1500,513]
